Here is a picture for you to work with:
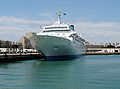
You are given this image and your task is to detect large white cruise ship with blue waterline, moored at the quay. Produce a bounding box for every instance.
[32,10,86,61]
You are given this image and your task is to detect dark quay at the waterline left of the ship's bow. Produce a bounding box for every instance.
[0,53,44,63]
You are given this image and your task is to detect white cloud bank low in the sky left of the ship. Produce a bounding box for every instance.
[0,16,50,40]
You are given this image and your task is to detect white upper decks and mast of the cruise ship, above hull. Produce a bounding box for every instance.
[37,11,84,42]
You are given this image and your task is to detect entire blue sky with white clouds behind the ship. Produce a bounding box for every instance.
[0,0,120,43]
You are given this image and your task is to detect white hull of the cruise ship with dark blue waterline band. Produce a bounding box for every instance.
[31,35,86,60]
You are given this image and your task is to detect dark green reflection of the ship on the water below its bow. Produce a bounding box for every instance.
[22,57,84,89]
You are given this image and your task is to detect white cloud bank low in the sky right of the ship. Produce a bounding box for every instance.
[75,22,120,43]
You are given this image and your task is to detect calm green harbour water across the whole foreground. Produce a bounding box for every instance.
[0,55,120,89]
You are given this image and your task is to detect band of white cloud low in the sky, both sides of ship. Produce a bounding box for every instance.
[0,16,120,43]
